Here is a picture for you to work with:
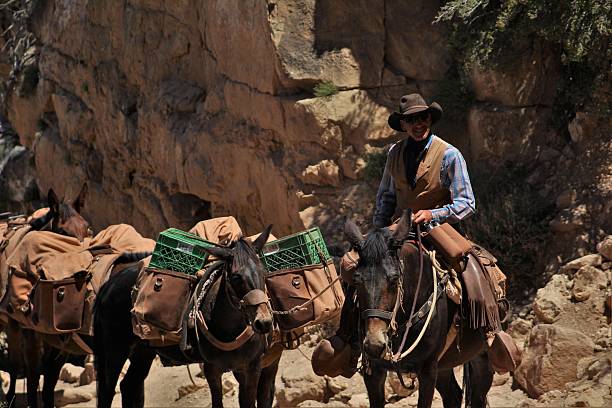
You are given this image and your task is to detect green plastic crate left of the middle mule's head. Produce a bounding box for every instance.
[149,228,215,275]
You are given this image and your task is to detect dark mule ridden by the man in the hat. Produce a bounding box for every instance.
[345,212,493,408]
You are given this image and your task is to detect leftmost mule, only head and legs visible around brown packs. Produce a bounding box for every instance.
[6,184,91,407]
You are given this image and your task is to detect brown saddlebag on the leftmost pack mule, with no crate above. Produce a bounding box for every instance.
[30,274,88,334]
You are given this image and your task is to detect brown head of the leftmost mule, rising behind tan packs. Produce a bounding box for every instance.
[47,183,92,241]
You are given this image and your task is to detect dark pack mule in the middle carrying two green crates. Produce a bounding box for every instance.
[94,226,276,408]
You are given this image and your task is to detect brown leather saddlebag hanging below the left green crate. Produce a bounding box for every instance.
[132,268,197,345]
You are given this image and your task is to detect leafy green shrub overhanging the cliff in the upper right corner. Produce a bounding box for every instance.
[435,0,612,122]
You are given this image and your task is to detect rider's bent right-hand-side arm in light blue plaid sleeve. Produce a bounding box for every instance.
[431,146,476,224]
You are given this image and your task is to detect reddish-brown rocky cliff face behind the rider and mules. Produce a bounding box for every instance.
[0,0,612,284]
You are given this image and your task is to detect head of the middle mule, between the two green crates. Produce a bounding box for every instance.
[205,225,273,334]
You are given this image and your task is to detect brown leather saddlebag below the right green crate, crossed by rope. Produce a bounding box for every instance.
[266,260,344,331]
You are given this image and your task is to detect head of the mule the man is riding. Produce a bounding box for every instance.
[344,211,412,358]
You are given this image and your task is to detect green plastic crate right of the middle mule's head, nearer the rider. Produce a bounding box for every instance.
[260,227,331,272]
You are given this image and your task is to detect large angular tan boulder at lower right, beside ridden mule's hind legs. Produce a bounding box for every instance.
[514,324,595,398]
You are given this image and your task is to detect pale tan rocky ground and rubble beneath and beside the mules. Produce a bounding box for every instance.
[3,236,612,408]
